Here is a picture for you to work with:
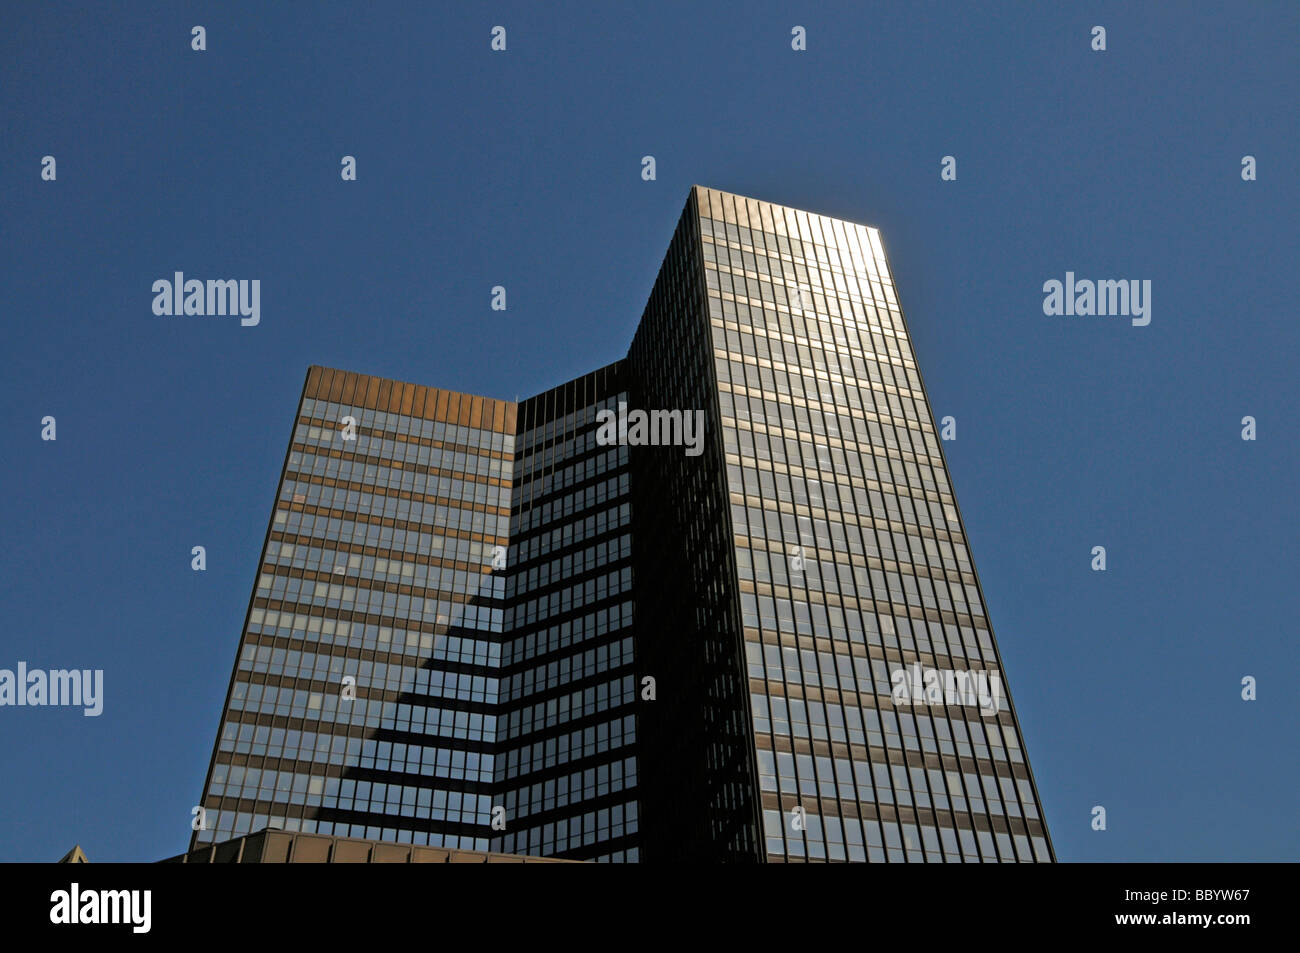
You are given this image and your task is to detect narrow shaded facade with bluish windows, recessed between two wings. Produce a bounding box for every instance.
[491,363,641,862]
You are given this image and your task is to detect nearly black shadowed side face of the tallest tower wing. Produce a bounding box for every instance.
[628,202,762,862]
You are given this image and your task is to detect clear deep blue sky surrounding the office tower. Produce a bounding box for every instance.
[0,3,1300,861]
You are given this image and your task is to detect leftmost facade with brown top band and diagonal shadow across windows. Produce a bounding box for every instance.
[192,368,515,850]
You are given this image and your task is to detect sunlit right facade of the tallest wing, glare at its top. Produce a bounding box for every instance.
[696,190,1052,862]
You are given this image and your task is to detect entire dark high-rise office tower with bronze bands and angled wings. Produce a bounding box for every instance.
[194,187,1053,862]
